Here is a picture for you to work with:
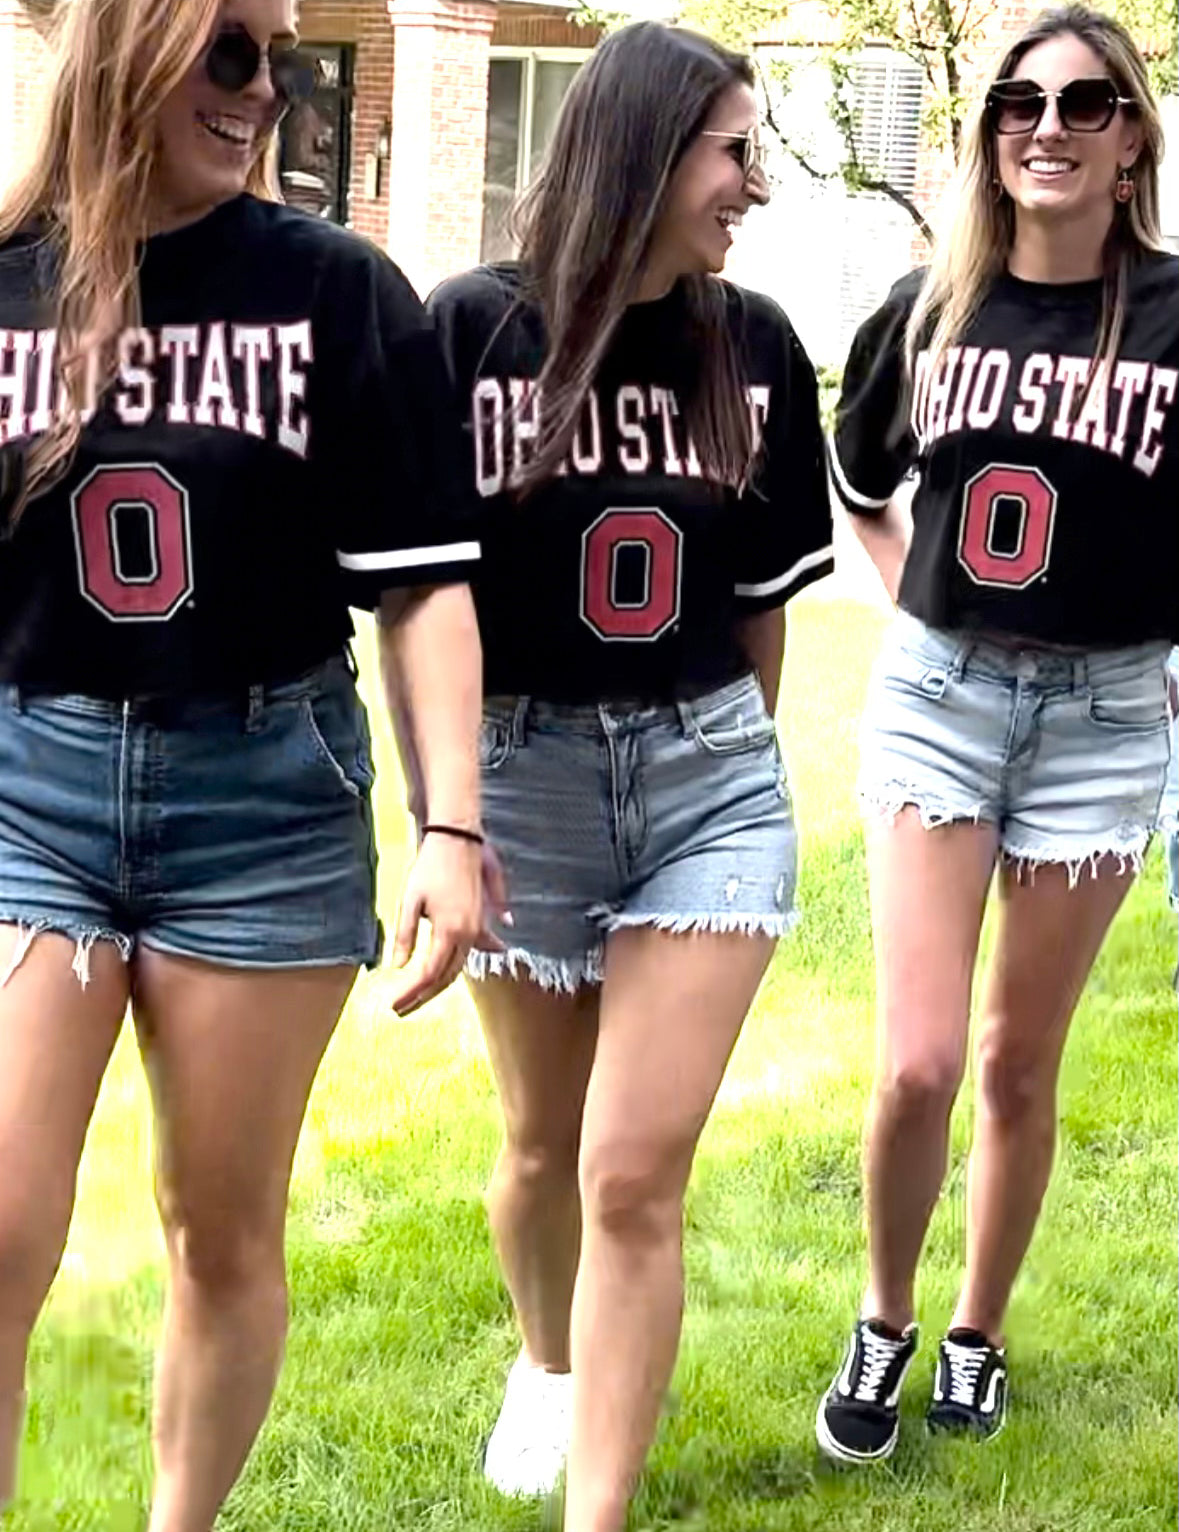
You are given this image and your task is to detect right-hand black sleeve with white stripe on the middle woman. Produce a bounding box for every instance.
[733,306,834,614]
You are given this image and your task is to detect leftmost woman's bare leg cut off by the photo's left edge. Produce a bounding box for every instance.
[0,925,127,1507]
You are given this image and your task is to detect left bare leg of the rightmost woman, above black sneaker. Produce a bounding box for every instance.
[862,809,997,1330]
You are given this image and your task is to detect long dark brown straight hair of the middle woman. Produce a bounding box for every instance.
[513,21,753,493]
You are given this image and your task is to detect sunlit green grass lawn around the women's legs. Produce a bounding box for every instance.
[9,599,1179,1532]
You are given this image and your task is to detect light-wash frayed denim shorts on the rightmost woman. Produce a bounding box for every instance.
[859,613,1170,882]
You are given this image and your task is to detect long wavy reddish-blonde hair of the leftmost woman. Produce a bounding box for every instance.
[0,0,277,519]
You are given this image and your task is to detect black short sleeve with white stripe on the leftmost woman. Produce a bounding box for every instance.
[311,241,479,608]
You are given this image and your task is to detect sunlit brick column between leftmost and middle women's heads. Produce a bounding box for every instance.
[389,0,496,294]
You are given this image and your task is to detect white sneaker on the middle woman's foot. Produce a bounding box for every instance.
[482,1353,573,1495]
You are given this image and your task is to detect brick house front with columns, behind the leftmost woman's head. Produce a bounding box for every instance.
[0,0,599,290]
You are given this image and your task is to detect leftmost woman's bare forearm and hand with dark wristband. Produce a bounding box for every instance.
[378,585,484,1016]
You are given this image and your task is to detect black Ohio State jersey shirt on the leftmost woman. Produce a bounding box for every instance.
[0,195,478,697]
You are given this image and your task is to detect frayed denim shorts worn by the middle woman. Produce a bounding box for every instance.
[467,676,798,991]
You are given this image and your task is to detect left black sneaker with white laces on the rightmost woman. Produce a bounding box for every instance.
[815,1319,917,1463]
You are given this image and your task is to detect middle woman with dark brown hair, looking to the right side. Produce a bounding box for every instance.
[430,23,831,1532]
